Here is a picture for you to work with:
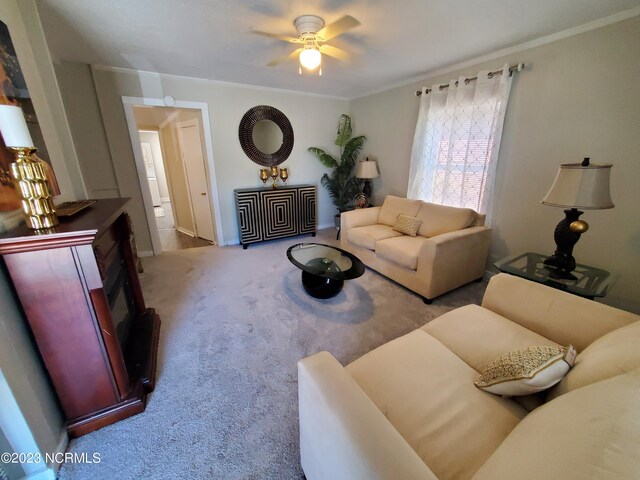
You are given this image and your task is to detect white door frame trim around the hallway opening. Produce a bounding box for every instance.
[122,95,224,255]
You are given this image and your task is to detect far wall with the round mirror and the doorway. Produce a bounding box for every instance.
[80,69,350,251]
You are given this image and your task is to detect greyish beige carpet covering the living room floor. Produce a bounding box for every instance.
[59,230,485,480]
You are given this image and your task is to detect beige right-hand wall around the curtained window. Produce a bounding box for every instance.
[350,17,640,312]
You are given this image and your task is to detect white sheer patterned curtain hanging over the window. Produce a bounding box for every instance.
[407,65,511,223]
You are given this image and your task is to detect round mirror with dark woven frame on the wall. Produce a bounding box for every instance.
[238,105,293,167]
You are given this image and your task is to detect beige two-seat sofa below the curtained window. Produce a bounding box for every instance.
[340,195,491,303]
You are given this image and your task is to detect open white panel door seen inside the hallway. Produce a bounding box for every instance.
[177,120,216,242]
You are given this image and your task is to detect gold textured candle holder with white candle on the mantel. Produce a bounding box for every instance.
[0,105,58,229]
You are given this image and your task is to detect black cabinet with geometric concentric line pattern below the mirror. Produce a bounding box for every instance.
[233,185,316,249]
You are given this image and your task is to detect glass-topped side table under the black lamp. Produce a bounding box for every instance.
[494,252,615,300]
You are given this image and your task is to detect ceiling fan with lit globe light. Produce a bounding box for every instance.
[252,15,360,75]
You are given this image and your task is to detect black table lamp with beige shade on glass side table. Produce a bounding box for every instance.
[542,158,614,279]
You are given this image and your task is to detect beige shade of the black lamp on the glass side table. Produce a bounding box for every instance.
[542,163,614,210]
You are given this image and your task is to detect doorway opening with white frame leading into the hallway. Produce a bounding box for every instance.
[123,97,221,254]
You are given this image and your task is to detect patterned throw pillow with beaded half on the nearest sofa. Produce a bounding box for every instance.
[474,345,576,396]
